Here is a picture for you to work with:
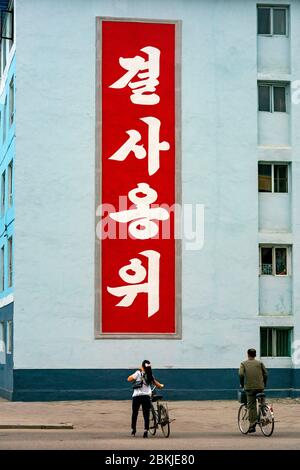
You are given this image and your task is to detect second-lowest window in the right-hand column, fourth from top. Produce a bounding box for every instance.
[260,246,288,276]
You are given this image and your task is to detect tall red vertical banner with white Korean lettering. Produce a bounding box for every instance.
[96,19,181,338]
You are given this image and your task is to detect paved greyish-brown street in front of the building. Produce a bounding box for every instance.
[0,399,300,450]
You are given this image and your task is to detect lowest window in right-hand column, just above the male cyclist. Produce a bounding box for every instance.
[260,328,292,357]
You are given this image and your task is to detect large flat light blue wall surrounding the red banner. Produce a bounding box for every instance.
[14,0,300,369]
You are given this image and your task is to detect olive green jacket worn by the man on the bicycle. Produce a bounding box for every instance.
[239,359,268,390]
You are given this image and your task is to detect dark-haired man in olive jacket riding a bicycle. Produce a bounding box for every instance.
[239,348,268,432]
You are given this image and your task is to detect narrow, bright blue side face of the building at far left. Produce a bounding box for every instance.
[0,2,16,393]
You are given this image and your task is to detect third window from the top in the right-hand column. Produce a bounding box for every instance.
[258,163,289,193]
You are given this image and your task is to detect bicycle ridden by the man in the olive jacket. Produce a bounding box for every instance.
[238,392,274,437]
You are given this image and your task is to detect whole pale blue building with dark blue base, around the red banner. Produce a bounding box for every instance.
[0,0,300,400]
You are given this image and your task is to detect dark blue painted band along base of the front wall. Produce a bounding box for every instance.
[12,369,300,401]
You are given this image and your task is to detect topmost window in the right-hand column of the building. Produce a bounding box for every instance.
[257,6,288,36]
